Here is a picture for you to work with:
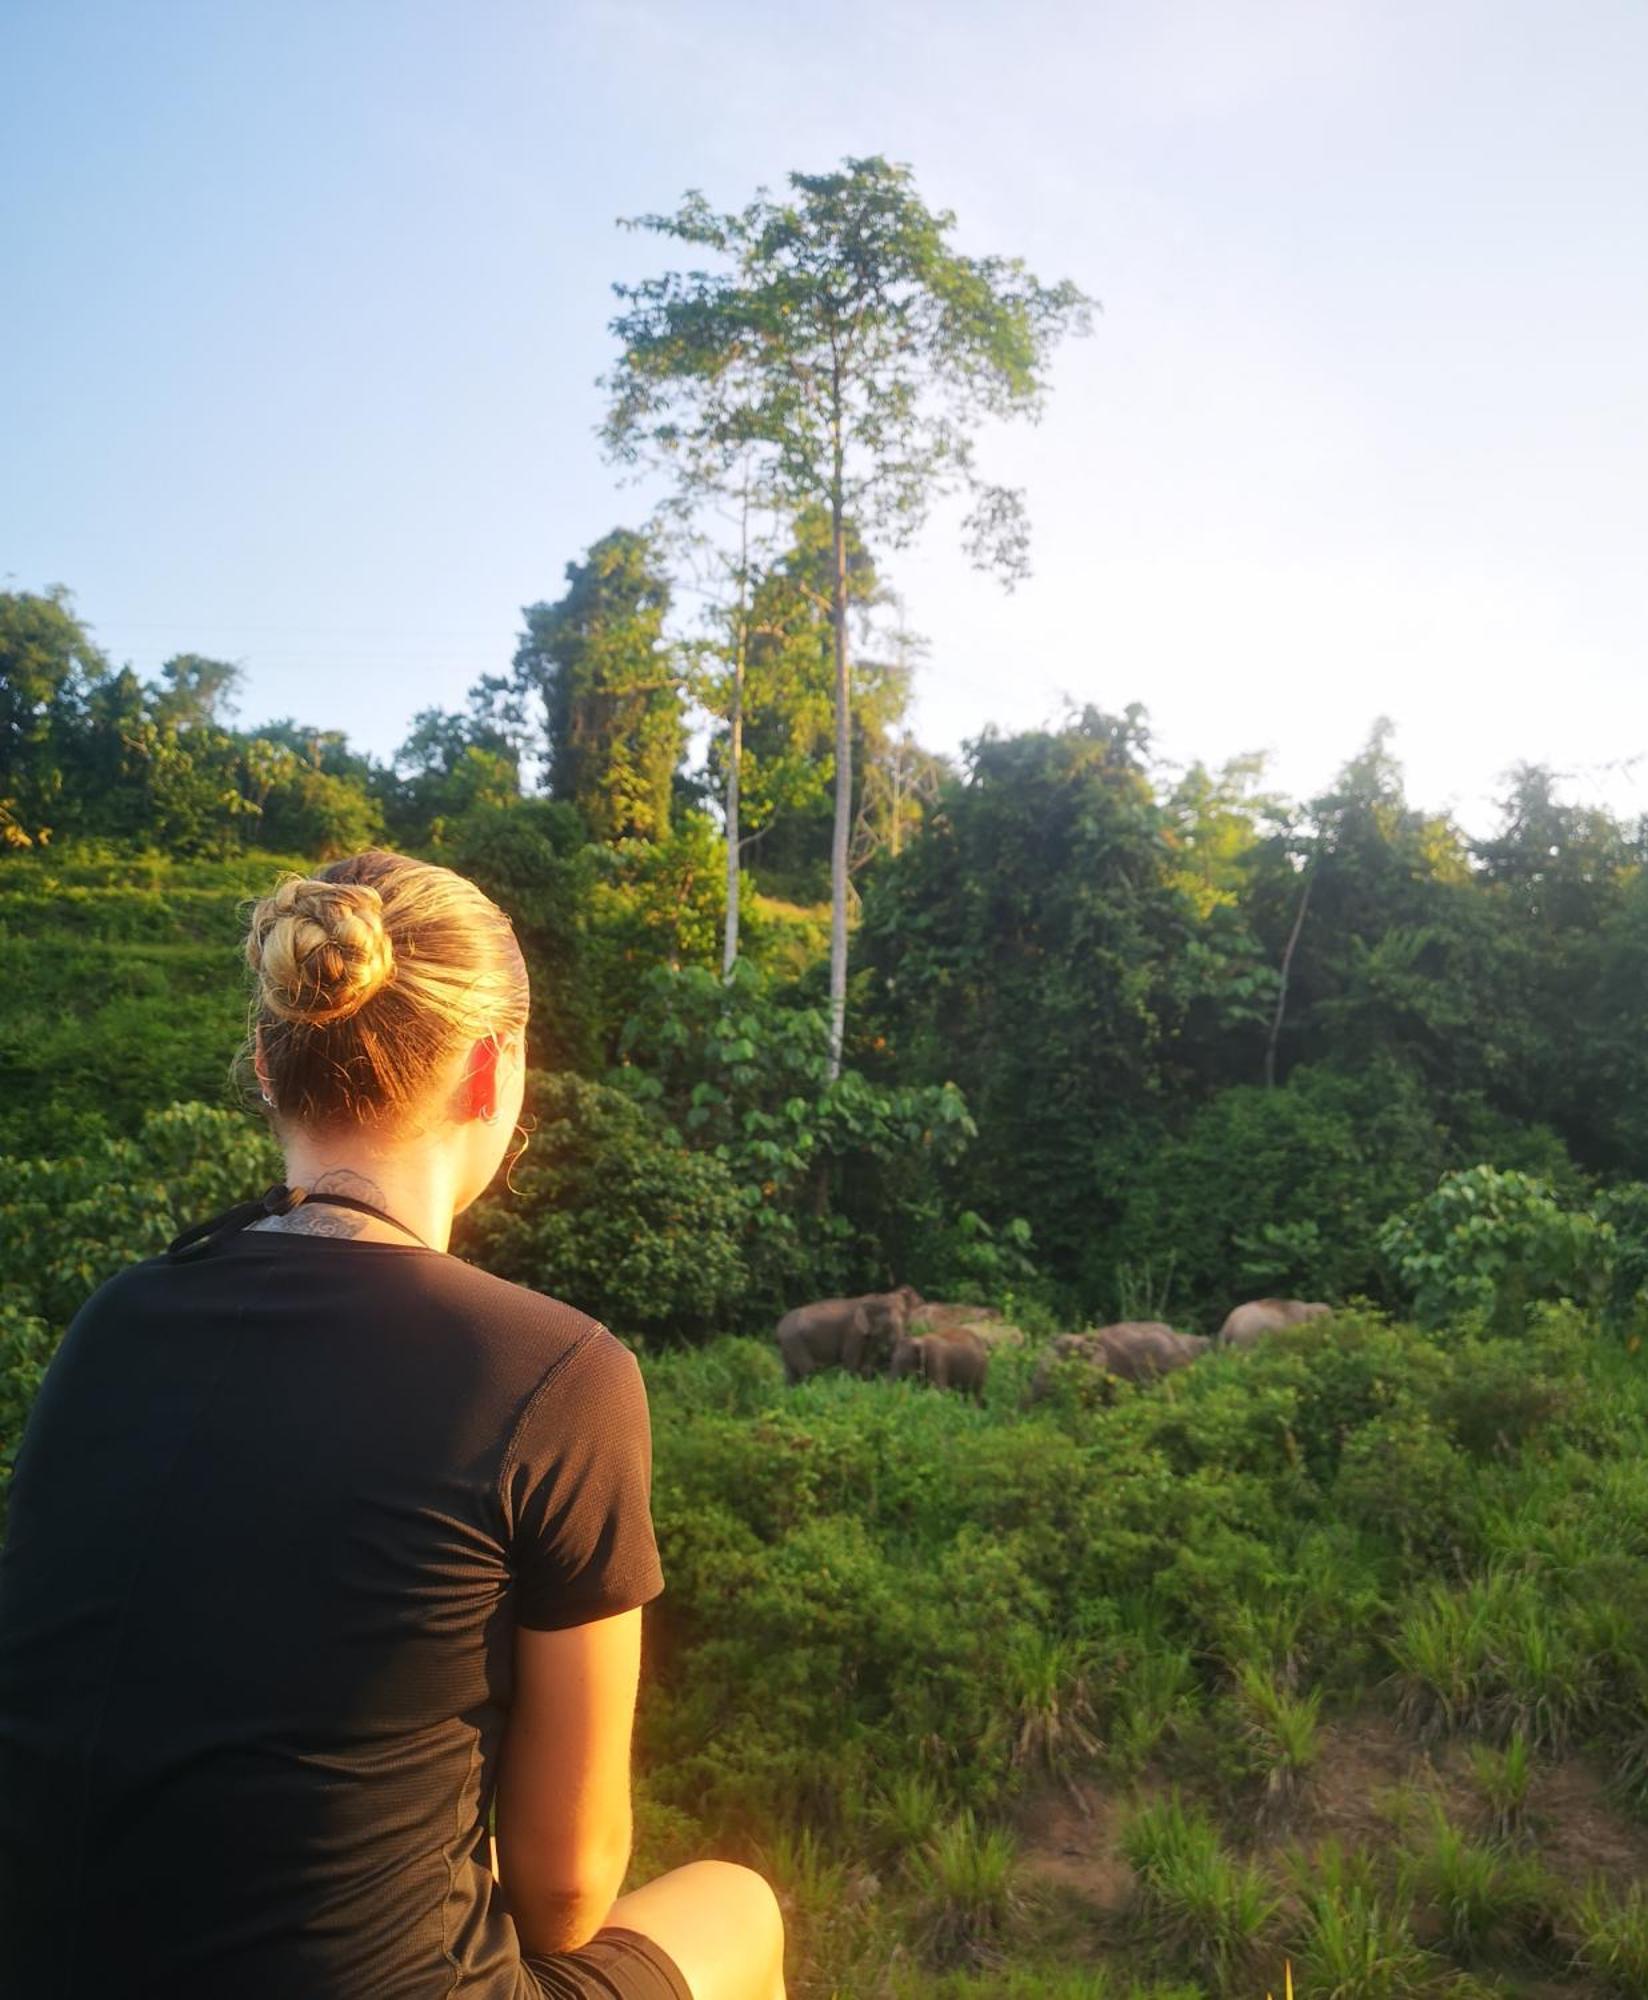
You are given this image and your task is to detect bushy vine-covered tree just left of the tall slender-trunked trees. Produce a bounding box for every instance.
[514,528,686,840]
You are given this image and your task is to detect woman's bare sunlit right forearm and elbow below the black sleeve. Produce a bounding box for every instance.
[498,1610,640,1954]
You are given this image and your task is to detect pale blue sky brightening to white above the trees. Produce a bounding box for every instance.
[0,0,1648,826]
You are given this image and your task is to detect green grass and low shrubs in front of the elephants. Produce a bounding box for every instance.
[642,1308,1648,2000]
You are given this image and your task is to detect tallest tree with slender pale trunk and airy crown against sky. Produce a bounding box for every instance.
[606,158,1090,1076]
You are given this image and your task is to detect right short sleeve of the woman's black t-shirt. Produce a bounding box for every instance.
[500,1326,664,1632]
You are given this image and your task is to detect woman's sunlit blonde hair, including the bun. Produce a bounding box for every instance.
[240,848,528,1128]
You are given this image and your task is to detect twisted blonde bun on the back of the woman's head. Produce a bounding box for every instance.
[246,876,394,1028]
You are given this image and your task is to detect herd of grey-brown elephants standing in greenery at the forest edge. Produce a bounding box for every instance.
[776,1284,1334,1402]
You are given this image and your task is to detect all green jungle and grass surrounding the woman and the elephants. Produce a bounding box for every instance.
[0,572,1648,2000]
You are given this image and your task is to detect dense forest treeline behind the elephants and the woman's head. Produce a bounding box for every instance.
[0,564,1648,1334]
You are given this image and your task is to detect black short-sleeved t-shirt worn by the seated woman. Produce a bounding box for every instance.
[0,1230,664,2000]
